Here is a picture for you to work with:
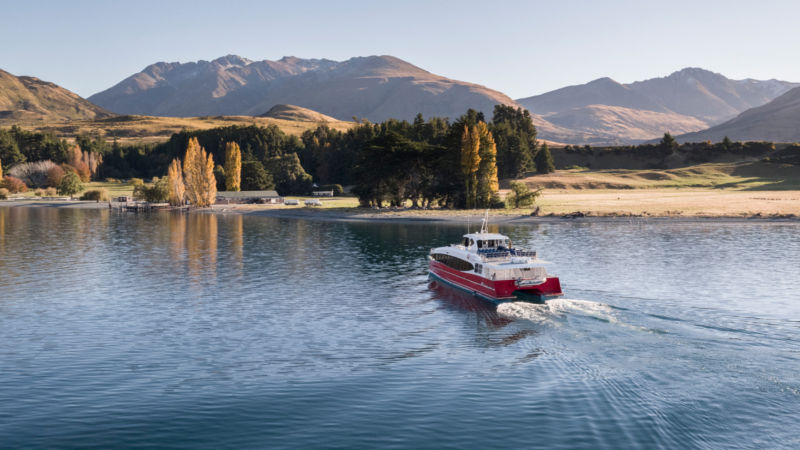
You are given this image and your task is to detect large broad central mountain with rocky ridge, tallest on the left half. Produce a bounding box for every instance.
[89,55,516,121]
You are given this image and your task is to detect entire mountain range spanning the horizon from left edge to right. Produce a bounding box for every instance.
[0,55,800,145]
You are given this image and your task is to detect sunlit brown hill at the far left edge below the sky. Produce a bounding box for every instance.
[0,70,114,123]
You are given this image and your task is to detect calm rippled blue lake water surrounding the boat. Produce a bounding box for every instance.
[0,207,800,449]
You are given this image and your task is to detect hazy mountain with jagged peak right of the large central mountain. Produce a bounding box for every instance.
[517,68,800,143]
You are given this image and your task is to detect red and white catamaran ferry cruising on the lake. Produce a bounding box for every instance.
[428,212,563,302]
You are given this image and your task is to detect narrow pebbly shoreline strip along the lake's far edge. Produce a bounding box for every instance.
[0,199,800,225]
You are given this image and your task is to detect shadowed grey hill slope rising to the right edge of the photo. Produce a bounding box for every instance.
[677,87,800,142]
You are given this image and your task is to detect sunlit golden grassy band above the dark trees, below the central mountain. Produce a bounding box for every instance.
[11,116,355,144]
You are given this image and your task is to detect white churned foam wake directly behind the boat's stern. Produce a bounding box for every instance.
[497,298,659,332]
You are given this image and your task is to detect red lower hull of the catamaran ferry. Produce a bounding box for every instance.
[428,260,563,301]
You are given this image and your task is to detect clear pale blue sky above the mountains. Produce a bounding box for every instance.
[0,0,800,99]
